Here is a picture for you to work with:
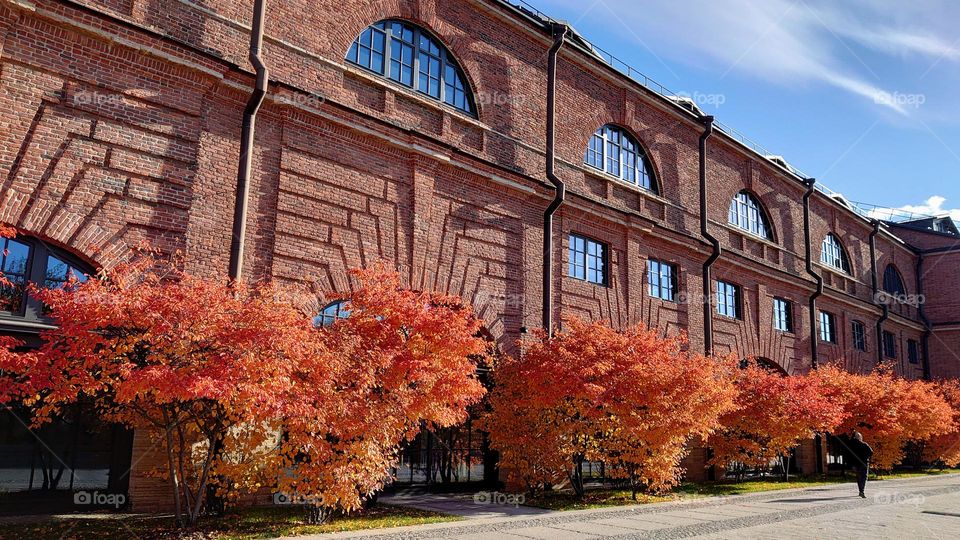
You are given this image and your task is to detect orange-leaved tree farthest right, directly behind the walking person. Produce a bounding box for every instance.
[814,366,953,470]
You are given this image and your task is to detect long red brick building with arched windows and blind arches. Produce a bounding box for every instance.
[0,0,960,508]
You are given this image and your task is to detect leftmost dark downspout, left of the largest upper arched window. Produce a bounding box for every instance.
[229,0,270,282]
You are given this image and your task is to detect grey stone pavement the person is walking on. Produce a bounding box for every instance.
[296,474,960,540]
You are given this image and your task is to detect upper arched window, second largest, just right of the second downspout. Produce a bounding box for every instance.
[583,125,657,193]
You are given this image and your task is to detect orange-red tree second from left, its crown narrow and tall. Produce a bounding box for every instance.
[280,265,487,521]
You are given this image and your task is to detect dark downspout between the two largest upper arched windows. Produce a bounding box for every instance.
[543,23,569,336]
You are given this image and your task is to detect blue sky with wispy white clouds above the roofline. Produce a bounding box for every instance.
[527,0,960,220]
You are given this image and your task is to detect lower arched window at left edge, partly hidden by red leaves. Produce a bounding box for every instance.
[0,236,93,324]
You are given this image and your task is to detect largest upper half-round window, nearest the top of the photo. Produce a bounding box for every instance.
[347,20,476,116]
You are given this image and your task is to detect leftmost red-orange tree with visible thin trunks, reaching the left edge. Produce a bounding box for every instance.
[0,256,322,525]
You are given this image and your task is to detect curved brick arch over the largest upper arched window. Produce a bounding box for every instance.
[333,5,484,119]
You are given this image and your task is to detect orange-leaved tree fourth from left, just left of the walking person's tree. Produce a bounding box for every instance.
[707,362,843,478]
